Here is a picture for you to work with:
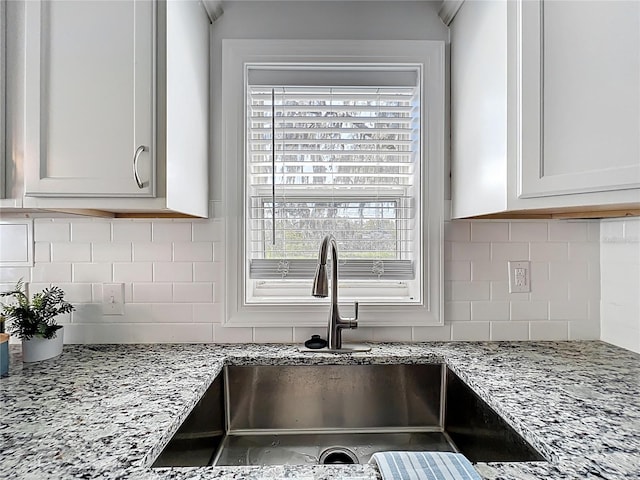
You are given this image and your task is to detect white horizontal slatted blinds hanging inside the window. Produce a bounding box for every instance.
[245,71,421,281]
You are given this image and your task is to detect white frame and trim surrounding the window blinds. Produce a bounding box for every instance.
[221,39,446,327]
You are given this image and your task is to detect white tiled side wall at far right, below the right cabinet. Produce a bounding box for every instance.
[600,218,640,353]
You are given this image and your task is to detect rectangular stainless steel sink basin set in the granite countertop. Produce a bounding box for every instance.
[153,364,544,467]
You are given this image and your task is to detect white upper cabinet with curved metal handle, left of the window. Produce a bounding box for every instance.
[18,0,210,217]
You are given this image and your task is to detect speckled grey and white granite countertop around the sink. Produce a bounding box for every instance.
[0,342,640,480]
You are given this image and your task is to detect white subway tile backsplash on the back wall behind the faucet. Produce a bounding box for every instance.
[0,218,608,343]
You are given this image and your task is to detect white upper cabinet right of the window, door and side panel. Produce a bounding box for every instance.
[451,0,640,218]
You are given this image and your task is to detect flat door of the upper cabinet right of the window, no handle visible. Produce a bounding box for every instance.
[518,0,640,198]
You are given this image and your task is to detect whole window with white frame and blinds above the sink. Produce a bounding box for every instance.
[223,40,444,326]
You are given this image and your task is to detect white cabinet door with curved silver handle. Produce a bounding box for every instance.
[25,0,155,197]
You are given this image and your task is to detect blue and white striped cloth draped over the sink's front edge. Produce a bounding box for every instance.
[369,452,482,480]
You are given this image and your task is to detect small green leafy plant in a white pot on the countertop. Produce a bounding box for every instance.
[0,280,75,362]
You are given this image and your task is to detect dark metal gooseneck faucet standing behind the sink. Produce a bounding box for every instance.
[311,235,358,350]
